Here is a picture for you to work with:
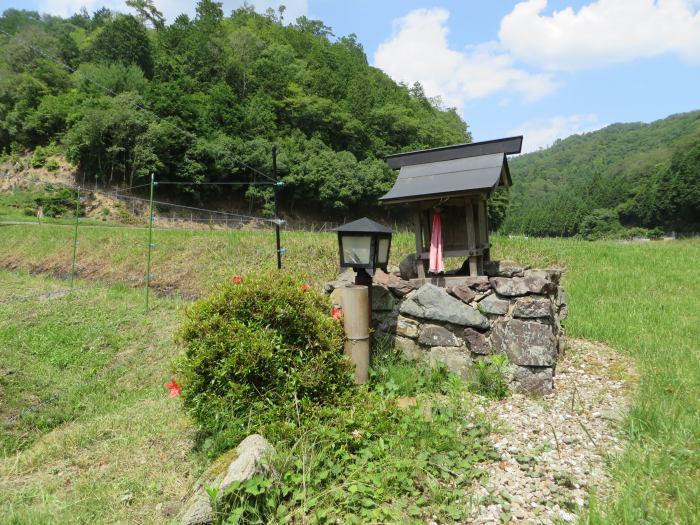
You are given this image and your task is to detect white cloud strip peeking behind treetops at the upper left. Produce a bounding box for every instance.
[39,0,309,23]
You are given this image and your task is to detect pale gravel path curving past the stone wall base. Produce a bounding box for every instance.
[469,340,636,524]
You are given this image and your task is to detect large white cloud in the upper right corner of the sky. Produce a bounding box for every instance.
[499,0,700,71]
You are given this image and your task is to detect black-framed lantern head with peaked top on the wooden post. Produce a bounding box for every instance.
[335,217,392,271]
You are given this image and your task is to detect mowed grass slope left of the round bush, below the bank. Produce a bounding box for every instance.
[0,270,201,524]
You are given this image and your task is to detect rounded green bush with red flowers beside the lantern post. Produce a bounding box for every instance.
[177,273,352,449]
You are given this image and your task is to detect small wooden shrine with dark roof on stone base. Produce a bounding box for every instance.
[379,136,523,279]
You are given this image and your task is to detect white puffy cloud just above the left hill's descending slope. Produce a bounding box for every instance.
[374,8,556,108]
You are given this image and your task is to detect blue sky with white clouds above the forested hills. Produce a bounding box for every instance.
[5,0,700,150]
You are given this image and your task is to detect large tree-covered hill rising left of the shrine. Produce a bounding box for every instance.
[0,0,470,216]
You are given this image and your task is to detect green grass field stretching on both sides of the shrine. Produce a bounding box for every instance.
[0,225,700,523]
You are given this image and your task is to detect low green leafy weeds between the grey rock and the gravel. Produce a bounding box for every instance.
[216,374,498,524]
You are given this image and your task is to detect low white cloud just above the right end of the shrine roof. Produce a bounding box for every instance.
[508,113,605,153]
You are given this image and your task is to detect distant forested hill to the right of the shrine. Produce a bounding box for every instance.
[503,111,700,237]
